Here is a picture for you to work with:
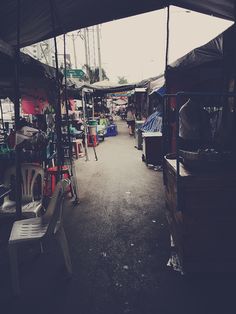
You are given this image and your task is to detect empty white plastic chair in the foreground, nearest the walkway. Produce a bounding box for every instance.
[8,179,72,295]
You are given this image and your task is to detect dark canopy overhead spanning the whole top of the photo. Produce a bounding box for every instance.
[0,0,234,46]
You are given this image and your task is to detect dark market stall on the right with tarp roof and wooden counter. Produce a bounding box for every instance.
[163,24,236,272]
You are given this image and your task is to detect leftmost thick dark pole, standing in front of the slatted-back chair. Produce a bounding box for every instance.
[14,0,22,219]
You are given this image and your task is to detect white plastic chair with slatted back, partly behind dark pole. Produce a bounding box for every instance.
[0,164,44,218]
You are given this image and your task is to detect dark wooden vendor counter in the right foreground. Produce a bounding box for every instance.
[163,158,236,272]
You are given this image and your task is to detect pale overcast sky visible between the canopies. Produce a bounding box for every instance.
[59,7,232,82]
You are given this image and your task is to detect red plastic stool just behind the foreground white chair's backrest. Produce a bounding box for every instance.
[45,166,74,197]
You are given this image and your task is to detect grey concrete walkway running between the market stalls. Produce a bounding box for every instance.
[0,121,236,314]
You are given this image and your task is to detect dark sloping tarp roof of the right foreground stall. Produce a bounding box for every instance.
[166,25,235,93]
